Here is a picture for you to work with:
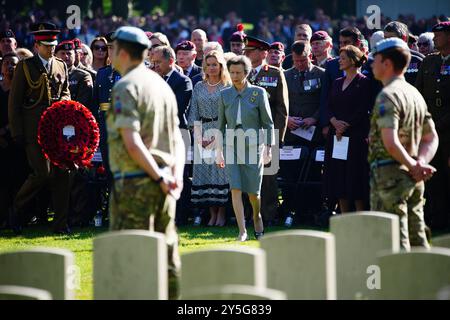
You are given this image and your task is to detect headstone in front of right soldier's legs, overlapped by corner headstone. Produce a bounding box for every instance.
[330,212,400,300]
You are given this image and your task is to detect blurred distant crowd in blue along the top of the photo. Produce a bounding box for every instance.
[0,8,446,54]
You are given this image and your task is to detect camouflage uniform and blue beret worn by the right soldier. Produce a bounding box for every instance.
[368,39,434,250]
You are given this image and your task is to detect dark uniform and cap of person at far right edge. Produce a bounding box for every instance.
[416,22,450,229]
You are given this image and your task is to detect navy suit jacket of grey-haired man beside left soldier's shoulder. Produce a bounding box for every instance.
[167,70,192,129]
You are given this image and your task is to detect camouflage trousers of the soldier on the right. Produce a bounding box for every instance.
[370,164,430,250]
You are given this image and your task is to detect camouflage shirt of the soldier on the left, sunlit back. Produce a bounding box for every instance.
[108,64,184,173]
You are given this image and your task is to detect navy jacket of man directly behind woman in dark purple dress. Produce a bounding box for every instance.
[319,58,344,127]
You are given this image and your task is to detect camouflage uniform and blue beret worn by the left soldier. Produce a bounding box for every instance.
[108,27,185,299]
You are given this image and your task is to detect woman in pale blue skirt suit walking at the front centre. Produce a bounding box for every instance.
[216,56,274,241]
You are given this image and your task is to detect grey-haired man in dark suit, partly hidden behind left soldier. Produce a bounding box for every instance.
[151,46,192,226]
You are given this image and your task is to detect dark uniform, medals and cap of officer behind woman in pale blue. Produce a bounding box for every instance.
[244,37,289,224]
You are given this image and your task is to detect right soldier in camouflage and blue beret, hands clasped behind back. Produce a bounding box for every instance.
[369,38,438,250]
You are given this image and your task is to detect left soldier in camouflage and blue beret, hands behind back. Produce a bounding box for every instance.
[107,27,185,299]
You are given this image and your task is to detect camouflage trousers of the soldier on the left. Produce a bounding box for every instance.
[110,178,181,300]
